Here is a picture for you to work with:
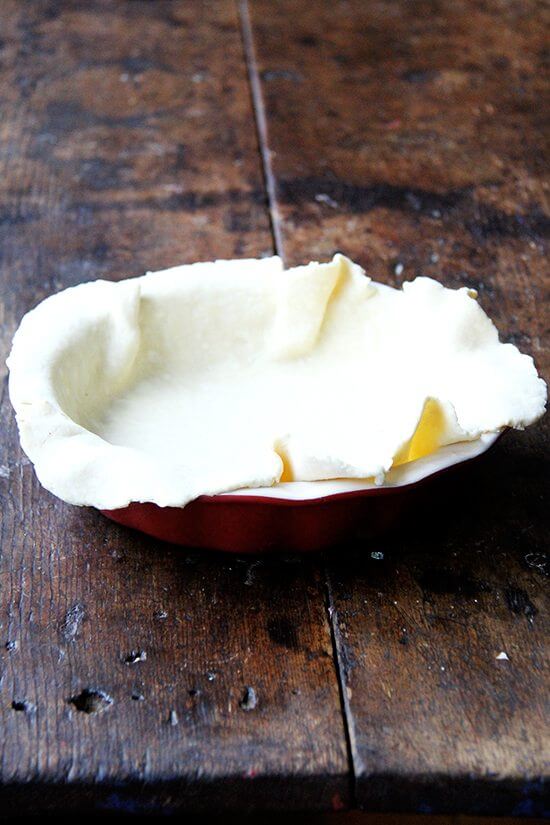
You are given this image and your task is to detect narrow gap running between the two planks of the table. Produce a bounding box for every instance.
[237,0,357,809]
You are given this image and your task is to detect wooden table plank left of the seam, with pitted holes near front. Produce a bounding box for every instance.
[0,0,348,813]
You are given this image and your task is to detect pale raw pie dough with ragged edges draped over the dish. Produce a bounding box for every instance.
[8,255,546,509]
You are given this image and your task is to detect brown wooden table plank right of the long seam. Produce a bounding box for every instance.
[250,0,550,815]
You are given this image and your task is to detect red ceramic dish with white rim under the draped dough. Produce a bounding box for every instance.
[102,434,498,553]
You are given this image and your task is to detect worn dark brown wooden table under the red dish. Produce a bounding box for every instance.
[0,0,549,815]
